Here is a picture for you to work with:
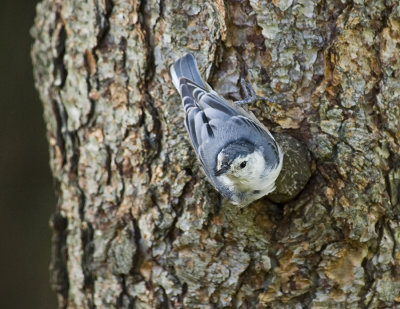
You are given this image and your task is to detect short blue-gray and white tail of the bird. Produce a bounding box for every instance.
[170,54,206,93]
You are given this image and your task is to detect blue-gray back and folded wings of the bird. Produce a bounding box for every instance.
[181,78,279,168]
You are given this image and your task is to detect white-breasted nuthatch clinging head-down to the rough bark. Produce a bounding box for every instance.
[171,54,283,206]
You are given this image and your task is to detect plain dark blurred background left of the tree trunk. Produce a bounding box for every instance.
[0,0,56,309]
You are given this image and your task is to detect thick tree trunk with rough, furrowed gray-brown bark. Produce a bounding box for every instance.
[32,0,400,308]
